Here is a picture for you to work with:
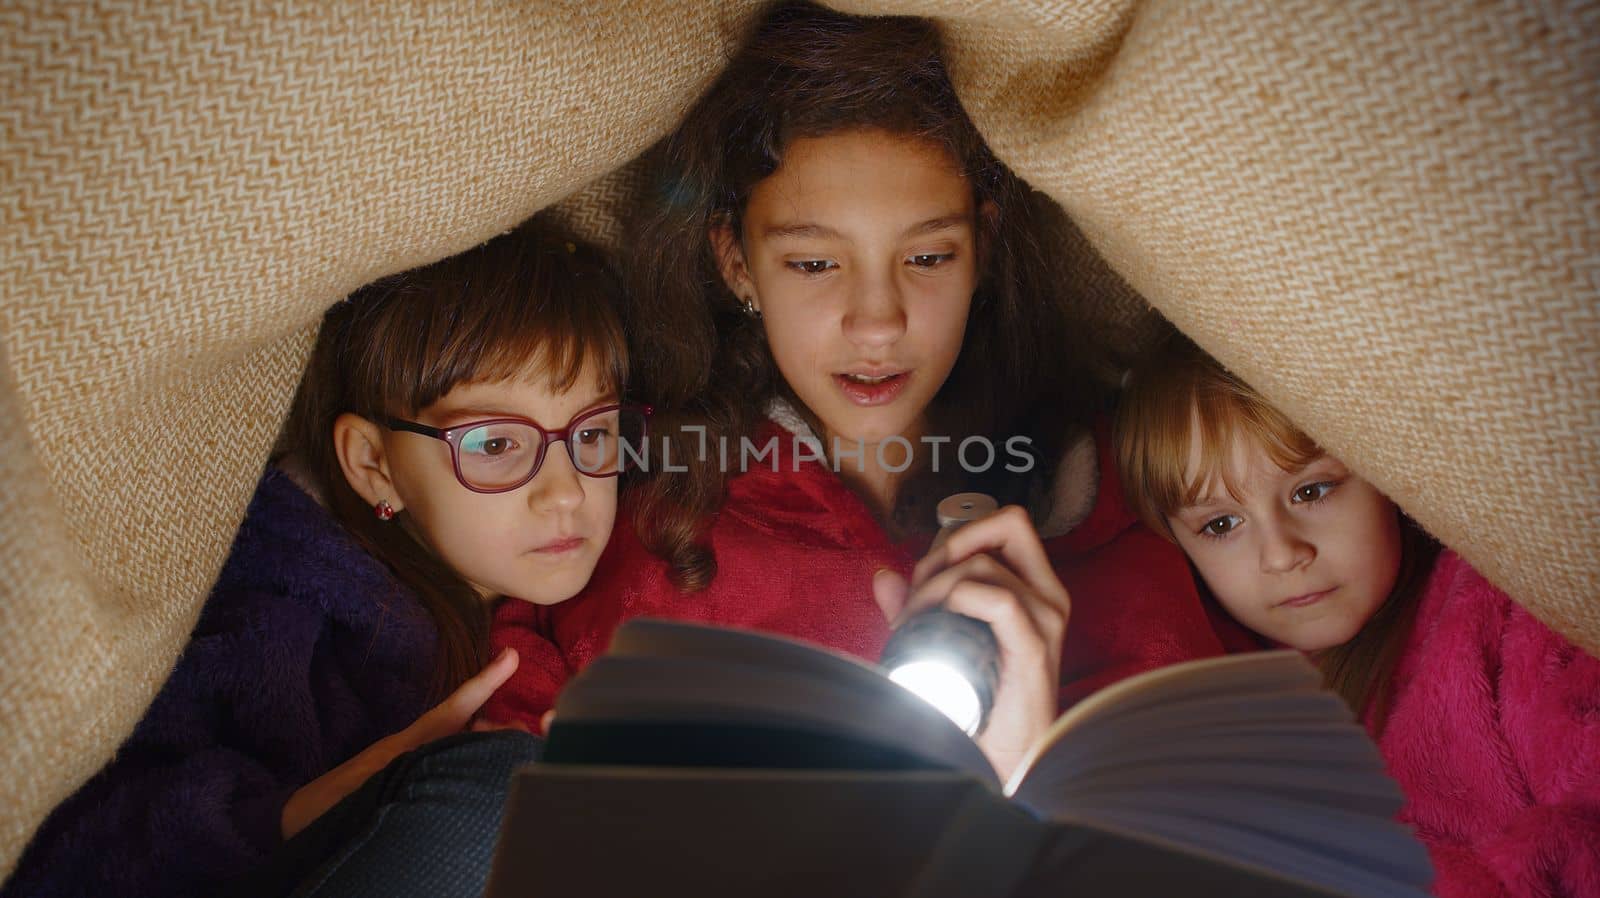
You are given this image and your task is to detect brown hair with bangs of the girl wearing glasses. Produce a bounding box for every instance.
[280,219,627,695]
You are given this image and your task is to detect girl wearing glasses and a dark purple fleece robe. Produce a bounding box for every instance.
[5,224,645,895]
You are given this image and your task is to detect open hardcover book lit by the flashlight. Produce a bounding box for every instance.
[488,619,1432,898]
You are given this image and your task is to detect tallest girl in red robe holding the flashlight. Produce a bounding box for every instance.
[486,5,1250,775]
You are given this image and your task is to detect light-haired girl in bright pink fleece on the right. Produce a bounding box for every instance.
[1117,338,1600,898]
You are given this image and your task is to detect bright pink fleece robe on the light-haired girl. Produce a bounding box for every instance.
[1379,551,1600,898]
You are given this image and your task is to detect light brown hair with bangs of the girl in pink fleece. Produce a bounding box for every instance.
[1114,335,1438,728]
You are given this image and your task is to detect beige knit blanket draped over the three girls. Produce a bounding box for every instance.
[0,0,1600,876]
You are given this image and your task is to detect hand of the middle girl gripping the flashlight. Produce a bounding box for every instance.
[872,506,1072,781]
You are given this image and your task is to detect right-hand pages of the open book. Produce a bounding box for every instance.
[1006,651,1432,898]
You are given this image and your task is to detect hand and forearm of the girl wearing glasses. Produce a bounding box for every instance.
[282,648,526,839]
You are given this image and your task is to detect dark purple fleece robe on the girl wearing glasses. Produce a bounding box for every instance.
[0,469,437,898]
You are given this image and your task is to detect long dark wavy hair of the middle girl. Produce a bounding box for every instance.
[627,3,1104,589]
